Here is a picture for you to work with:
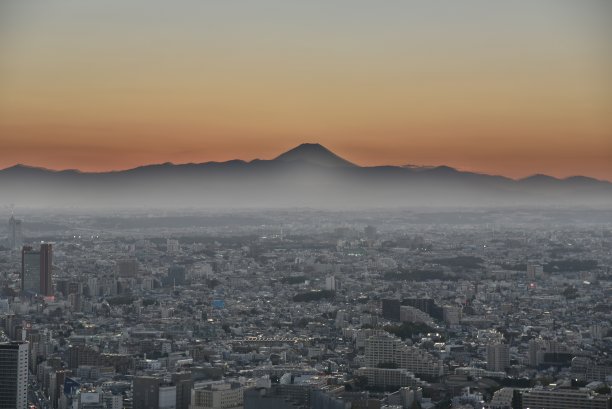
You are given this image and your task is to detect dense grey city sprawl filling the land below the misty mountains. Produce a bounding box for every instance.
[0,209,612,409]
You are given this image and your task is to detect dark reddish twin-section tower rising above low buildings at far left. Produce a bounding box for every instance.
[21,243,53,296]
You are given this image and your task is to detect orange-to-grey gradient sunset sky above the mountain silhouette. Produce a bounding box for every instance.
[0,0,612,180]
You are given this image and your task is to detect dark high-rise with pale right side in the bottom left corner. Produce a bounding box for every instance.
[0,342,29,409]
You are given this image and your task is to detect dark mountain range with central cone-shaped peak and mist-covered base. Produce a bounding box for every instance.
[0,143,612,208]
